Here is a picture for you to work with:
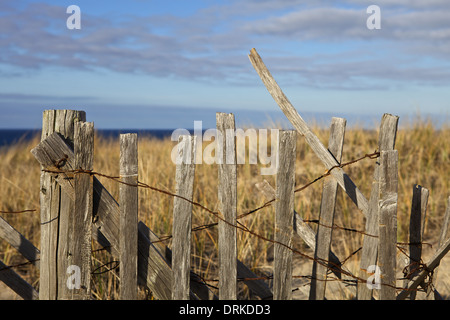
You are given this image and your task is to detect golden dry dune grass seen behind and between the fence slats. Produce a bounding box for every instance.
[0,121,450,299]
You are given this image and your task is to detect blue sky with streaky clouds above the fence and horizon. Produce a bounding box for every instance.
[0,0,450,129]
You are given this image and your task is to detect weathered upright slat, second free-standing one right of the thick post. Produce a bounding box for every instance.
[172,135,197,300]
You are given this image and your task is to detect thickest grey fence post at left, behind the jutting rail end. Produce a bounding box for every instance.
[39,110,86,300]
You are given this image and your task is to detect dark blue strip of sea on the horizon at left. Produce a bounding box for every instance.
[0,129,183,147]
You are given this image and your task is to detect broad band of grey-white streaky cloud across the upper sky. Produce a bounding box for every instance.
[0,0,450,89]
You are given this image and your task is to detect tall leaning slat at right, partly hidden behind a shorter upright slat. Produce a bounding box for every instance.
[357,113,399,300]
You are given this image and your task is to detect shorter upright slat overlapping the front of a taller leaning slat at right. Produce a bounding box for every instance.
[378,150,398,300]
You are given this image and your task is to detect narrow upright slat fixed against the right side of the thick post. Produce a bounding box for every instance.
[63,122,94,300]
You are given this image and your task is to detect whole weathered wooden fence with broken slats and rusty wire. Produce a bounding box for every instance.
[0,50,450,300]
